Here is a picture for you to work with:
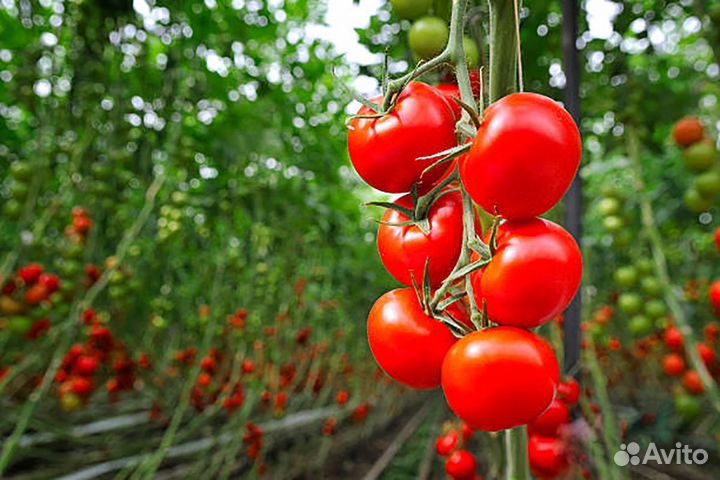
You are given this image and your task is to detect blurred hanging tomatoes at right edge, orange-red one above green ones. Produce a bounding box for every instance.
[673,117,720,213]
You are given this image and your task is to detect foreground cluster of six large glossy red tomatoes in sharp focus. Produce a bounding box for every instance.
[348,71,582,438]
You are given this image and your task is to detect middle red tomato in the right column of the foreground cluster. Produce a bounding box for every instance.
[471,218,582,328]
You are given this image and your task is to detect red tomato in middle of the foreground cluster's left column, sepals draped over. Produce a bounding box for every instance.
[378,191,463,287]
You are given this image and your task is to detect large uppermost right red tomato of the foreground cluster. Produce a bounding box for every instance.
[460,93,582,219]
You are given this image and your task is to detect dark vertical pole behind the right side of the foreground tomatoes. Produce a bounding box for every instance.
[562,0,582,374]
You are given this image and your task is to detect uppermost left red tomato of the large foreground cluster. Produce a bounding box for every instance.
[348,82,457,193]
